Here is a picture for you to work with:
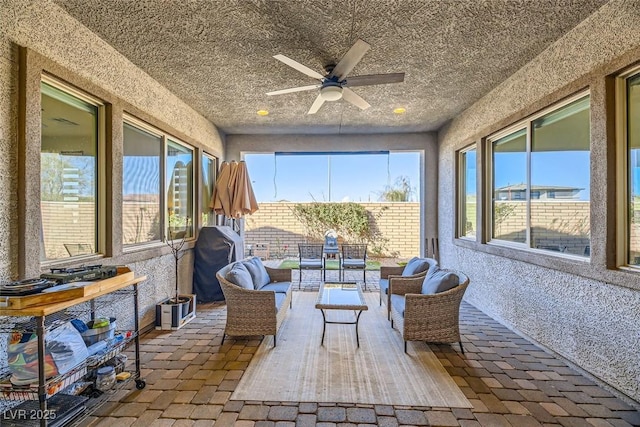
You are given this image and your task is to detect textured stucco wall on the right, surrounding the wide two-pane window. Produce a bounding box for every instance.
[438,1,640,400]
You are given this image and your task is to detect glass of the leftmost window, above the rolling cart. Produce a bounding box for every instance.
[40,81,101,260]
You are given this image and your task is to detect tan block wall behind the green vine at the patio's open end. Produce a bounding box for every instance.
[244,202,420,258]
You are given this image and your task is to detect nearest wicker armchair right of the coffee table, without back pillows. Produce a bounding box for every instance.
[389,270,469,353]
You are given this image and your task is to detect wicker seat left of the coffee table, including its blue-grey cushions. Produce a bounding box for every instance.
[216,257,292,347]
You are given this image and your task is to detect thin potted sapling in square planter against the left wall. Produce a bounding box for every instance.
[156,217,195,329]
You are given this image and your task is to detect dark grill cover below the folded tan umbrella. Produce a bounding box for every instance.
[193,226,244,303]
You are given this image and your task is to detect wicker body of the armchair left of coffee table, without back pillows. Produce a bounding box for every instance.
[216,264,292,347]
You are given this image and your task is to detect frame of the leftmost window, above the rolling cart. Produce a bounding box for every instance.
[37,75,109,267]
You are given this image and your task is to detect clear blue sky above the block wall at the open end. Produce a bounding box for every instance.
[244,151,420,202]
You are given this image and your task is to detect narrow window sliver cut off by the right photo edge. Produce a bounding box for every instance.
[625,70,640,265]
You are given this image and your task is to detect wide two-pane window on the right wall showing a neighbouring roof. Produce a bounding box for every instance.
[489,95,591,257]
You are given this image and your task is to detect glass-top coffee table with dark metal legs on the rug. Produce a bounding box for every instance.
[316,282,369,347]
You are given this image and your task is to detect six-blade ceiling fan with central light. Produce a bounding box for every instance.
[267,40,404,114]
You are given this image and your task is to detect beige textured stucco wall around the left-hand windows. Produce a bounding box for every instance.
[0,0,224,327]
